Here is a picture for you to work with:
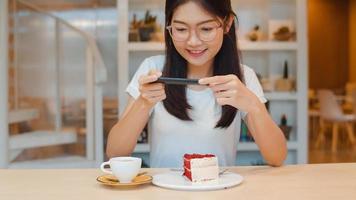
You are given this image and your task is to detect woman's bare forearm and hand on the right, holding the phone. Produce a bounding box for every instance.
[199,75,287,166]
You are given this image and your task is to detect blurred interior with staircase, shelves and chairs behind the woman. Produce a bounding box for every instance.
[0,0,356,168]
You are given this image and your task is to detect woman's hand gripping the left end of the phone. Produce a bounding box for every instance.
[138,70,166,108]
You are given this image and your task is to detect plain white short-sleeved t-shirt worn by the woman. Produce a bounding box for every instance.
[126,55,266,167]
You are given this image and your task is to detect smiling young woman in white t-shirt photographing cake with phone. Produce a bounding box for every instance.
[107,0,287,167]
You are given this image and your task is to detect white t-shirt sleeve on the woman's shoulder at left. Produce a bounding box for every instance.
[126,56,164,99]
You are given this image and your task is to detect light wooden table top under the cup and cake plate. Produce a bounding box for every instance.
[0,163,356,200]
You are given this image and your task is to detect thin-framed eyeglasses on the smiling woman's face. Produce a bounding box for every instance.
[167,22,223,42]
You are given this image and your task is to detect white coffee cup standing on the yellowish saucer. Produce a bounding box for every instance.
[100,157,142,183]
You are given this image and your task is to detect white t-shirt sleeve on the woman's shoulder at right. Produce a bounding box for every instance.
[241,65,267,119]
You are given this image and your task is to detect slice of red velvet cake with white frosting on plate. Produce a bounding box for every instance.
[183,154,219,183]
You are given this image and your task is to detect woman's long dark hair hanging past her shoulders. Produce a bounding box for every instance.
[163,0,244,128]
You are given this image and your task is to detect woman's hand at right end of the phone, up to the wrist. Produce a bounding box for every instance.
[199,74,262,112]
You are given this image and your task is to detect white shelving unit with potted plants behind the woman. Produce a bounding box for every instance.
[117,0,308,163]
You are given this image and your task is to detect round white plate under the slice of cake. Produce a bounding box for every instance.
[152,172,243,190]
